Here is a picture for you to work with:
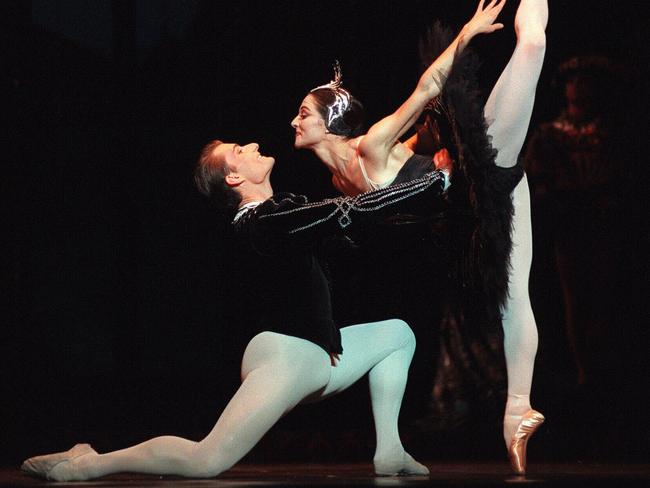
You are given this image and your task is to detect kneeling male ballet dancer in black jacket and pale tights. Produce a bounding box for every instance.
[17,141,449,481]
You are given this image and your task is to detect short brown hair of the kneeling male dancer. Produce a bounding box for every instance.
[194,140,241,211]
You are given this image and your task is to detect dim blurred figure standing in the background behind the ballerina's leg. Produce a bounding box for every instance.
[525,56,632,386]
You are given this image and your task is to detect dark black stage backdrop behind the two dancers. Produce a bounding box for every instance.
[0,0,648,465]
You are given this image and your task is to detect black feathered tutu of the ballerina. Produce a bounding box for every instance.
[415,23,523,324]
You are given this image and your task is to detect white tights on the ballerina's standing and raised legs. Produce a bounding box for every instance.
[485,0,548,446]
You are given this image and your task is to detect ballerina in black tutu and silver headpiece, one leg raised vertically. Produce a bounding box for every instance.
[291,0,548,474]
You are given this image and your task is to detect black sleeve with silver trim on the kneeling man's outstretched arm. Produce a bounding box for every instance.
[256,170,449,242]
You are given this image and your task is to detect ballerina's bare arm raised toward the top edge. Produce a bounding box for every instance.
[358,0,505,173]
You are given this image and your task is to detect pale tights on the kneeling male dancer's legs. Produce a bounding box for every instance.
[45,320,426,481]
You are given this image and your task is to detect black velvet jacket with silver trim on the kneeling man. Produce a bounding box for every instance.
[233,171,445,353]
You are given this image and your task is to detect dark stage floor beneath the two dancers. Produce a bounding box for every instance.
[0,462,650,488]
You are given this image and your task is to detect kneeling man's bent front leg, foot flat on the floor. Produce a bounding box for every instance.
[320,319,429,475]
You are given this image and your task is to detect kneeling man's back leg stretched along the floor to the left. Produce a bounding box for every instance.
[24,332,331,481]
